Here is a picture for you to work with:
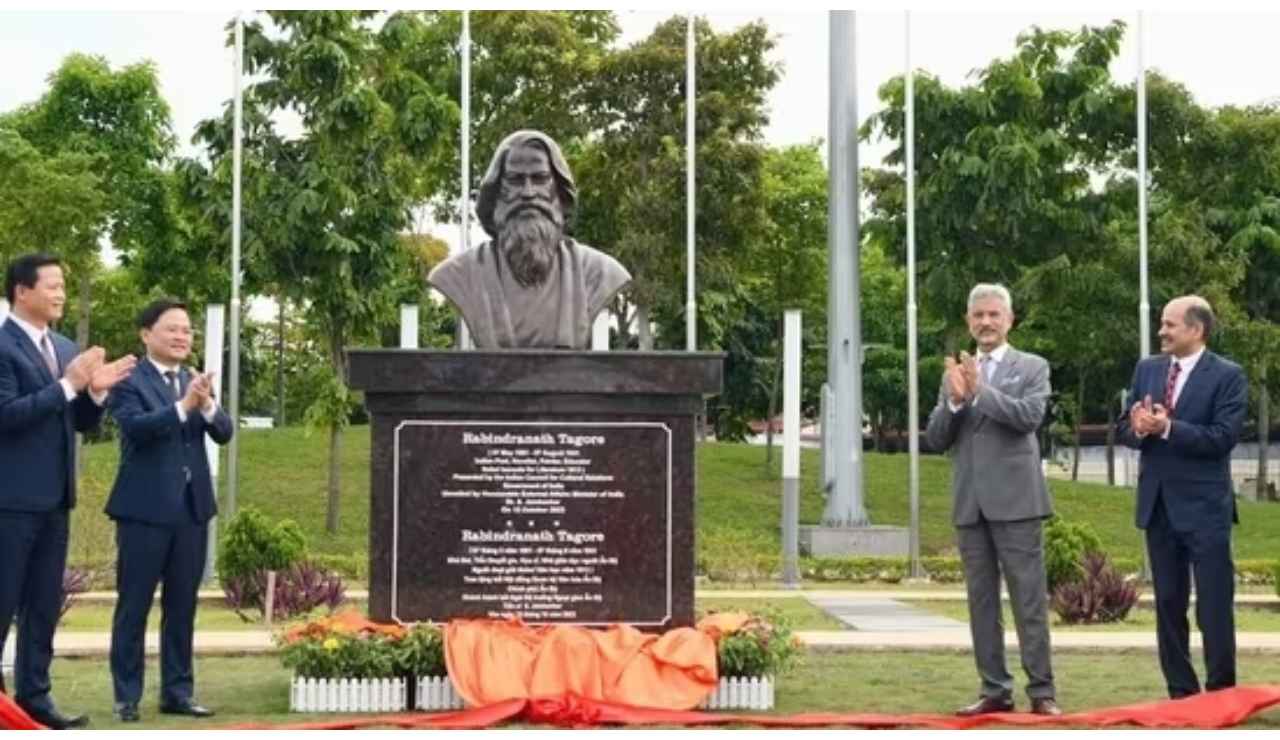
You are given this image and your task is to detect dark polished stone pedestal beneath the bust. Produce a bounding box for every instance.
[349,350,723,630]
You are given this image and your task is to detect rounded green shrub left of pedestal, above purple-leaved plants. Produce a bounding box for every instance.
[218,507,307,608]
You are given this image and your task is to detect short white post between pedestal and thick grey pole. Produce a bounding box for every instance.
[782,309,800,581]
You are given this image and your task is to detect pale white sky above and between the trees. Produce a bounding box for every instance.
[0,8,1280,314]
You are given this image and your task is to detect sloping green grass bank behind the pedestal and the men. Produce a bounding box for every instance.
[70,426,1280,570]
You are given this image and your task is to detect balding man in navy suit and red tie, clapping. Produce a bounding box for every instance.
[1117,290,1249,699]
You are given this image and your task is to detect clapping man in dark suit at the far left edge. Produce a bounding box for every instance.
[0,255,134,730]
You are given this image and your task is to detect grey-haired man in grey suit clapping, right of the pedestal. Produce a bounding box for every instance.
[925,283,1061,716]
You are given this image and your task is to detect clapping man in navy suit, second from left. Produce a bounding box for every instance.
[106,298,232,722]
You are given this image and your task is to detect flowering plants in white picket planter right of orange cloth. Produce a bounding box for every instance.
[705,615,800,709]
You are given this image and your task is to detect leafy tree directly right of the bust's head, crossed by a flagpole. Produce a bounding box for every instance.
[577,17,778,350]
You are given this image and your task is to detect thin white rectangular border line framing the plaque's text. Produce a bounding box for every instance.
[390,419,673,626]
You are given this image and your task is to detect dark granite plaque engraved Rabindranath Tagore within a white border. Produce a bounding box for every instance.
[392,420,672,626]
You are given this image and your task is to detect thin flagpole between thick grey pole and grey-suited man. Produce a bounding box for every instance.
[904,10,924,579]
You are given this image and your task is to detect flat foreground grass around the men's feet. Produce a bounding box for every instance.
[35,652,1280,730]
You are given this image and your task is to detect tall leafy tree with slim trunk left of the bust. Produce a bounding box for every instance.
[187,10,457,533]
